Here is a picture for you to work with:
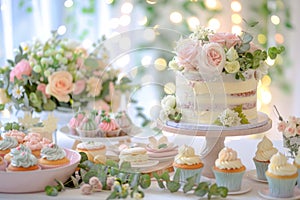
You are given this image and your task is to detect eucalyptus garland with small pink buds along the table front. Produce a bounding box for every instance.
[45,152,228,199]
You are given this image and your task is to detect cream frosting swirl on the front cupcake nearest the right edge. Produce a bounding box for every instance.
[268,152,297,176]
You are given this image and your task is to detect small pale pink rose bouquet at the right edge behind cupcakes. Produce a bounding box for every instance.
[274,106,300,158]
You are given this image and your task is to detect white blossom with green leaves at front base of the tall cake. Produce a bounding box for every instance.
[214,105,249,127]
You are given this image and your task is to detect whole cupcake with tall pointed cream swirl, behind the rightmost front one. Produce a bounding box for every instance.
[253,136,278,180]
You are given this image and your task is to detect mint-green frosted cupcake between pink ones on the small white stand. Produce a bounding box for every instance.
[77,117,99,137]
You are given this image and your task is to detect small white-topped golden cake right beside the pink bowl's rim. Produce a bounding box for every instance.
[76,141,106,162]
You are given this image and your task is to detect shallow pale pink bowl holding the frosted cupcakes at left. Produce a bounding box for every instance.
[0,149,81,193]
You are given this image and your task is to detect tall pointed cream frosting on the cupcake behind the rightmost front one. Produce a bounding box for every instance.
[254,136,278,161]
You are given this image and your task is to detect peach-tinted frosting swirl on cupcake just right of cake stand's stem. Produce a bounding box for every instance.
[215,147,243,169]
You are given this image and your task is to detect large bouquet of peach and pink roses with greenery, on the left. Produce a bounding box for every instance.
[0,32,129,111]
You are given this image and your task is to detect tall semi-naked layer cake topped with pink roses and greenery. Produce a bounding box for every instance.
[160,27,284,126]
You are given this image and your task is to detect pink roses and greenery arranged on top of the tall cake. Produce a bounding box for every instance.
[169,27,284,80]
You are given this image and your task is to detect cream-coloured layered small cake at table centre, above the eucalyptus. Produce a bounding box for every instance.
[119,147,148,165]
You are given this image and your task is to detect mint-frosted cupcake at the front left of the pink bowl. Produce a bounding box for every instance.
[6,151,43,171]
